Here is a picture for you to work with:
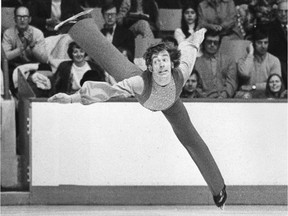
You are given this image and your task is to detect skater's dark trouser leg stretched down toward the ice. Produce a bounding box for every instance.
[163,99,224,196]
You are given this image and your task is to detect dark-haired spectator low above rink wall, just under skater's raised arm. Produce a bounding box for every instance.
[180,70,205,98]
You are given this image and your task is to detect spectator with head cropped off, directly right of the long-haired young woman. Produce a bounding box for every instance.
[198,0,243,39]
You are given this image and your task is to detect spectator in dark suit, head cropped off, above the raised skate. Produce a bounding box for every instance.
[31,0,83,37]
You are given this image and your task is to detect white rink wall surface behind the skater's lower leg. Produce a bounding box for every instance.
[30,102,288,186]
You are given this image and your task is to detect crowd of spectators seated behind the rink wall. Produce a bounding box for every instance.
[1,0,288,99]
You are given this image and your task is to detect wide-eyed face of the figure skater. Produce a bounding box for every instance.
[149,50,173,86]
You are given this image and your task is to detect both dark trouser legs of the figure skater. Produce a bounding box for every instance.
[69,19,224,195]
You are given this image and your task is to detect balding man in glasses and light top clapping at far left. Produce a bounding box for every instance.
[2,6,48,92]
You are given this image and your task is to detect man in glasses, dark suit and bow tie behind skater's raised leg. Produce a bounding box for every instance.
[101,4,135,59]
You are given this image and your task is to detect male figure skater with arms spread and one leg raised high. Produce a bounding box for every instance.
[48,19,227,208]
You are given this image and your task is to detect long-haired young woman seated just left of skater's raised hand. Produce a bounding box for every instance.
[174,3,198,44]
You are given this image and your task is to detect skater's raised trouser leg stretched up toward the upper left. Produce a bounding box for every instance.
[68,19,142,82]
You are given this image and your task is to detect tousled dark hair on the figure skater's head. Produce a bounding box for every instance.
[143,42,181,68]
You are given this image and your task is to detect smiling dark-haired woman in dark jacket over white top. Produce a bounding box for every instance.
[52,42,105,94]
